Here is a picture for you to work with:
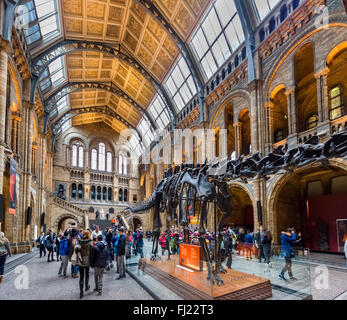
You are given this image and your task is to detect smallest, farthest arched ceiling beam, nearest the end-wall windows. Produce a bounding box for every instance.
[52,106,142,141]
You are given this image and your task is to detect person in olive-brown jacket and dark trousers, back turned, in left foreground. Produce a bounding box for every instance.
[75,230,93,299]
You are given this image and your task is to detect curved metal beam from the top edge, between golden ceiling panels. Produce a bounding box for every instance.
[134,0,208,122]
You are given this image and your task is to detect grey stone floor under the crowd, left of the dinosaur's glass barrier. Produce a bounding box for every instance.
[0,254,153,300]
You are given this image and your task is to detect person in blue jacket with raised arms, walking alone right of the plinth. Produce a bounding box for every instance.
[279,228,296,280]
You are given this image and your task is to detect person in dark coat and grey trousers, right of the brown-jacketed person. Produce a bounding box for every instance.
[90,235,108,296]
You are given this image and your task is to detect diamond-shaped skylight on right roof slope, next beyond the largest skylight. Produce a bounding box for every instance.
[165,56,197,111]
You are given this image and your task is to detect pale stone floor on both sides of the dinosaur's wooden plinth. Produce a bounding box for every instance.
[0,241,347,300]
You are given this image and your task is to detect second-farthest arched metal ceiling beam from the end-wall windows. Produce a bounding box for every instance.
[44,81,158,130]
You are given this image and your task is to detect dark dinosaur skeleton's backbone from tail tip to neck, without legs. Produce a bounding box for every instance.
[128,128,347,212]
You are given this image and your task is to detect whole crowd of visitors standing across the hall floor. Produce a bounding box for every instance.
[0,220,347,292]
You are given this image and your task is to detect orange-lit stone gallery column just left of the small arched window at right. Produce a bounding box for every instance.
[315,67,330,122]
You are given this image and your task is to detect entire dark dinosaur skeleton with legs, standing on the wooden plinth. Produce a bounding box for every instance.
[127,129,347,285]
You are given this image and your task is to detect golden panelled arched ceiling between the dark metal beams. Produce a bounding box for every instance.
[35,0,211,132]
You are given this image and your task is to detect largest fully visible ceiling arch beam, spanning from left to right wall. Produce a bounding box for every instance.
[30,40,177,126]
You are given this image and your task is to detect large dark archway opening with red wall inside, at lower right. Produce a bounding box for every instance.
[274,166,347,252]
